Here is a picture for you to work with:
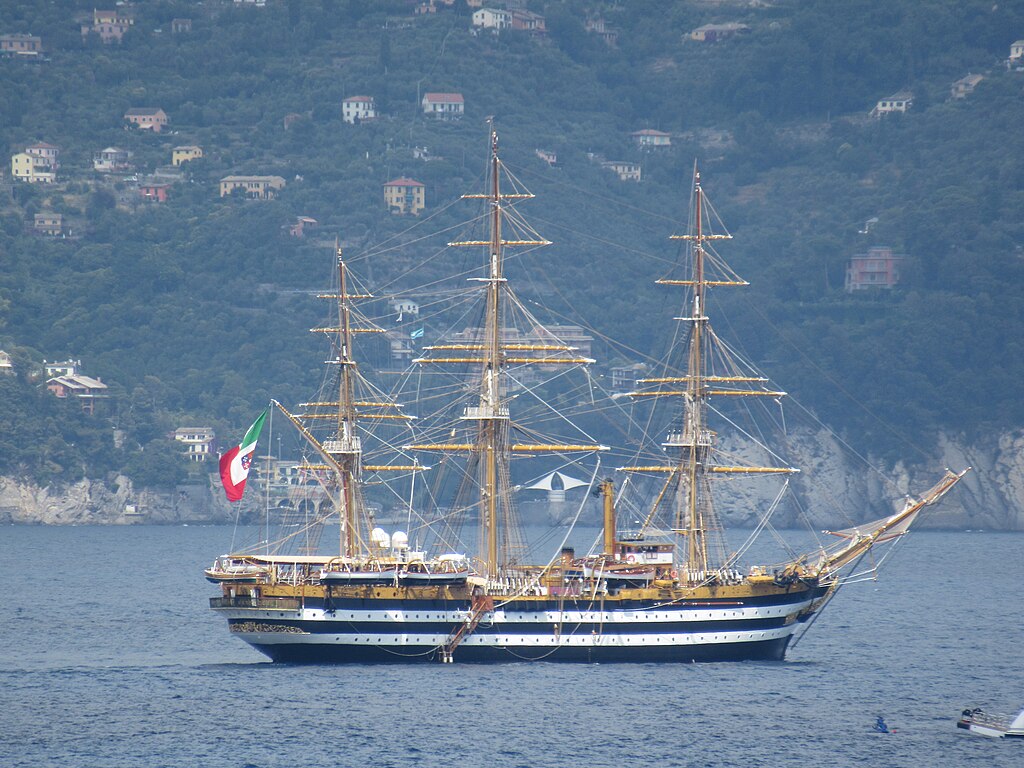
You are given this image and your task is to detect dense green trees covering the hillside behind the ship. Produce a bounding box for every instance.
[0,0,1024,485]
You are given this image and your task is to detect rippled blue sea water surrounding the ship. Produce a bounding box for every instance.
[0,526,1024,768]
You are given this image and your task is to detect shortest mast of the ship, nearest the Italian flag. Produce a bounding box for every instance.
[274,244,415,560]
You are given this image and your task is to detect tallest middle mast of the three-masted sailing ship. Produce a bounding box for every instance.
[403,124,607,579]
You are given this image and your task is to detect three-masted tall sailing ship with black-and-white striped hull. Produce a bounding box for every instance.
[206,129,967,663]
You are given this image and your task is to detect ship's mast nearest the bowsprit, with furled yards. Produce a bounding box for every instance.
[621,168,798,584]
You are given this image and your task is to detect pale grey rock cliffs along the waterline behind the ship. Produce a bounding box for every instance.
[0,429,1024,530]
